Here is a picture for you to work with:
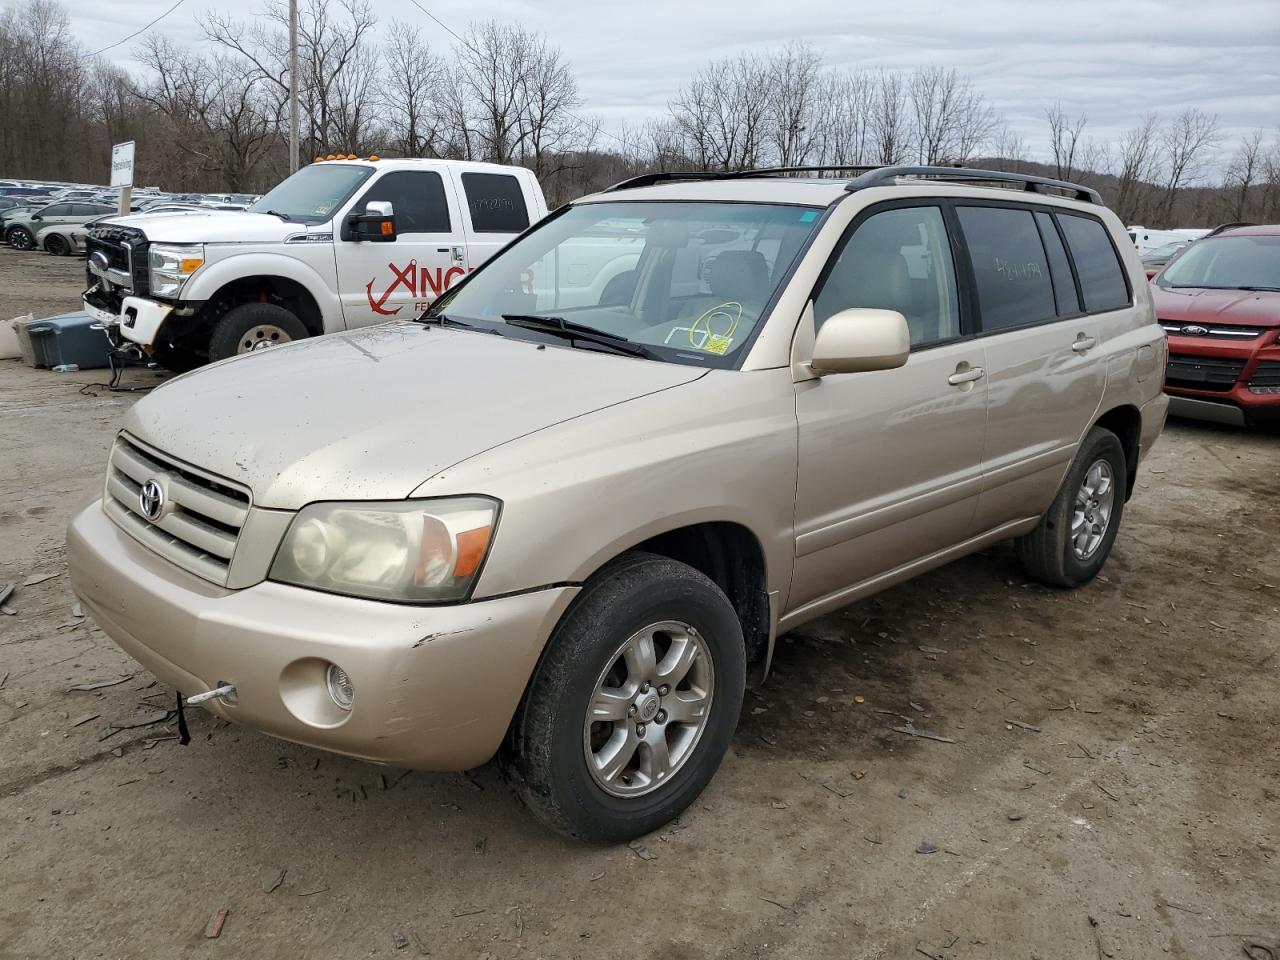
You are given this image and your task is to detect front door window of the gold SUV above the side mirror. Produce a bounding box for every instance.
[813,206,960,347]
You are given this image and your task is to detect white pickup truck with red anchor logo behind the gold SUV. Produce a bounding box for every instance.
[84,157,547,370]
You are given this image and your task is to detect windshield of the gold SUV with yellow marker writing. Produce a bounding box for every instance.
[433,201,822,366]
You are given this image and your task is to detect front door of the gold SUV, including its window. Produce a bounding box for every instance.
[787,204,987,612]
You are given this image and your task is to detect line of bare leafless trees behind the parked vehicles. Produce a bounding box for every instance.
[0,0,1280,227]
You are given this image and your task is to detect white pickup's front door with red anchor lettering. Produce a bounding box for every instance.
[334,170,467,328]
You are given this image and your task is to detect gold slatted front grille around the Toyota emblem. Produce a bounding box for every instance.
[102,434,250,585]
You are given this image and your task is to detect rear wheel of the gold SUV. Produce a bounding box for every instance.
[1016,426,1128,586]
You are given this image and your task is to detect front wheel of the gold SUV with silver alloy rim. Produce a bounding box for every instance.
[502,553,746,841]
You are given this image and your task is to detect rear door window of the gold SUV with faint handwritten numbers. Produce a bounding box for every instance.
[956,206,1057,330]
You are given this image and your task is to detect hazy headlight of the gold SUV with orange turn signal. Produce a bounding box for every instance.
[270,497,499,603]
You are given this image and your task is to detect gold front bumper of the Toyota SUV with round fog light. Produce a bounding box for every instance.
[67,502,577,771]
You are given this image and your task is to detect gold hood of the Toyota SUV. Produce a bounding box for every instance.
[124,321,705,509]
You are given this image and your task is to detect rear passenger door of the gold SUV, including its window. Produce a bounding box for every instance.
[956,201,1106,531]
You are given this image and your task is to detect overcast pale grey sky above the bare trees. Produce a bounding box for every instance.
[67,0,1280,170]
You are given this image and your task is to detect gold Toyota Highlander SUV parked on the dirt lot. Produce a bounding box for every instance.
[68,168,1167,840]
